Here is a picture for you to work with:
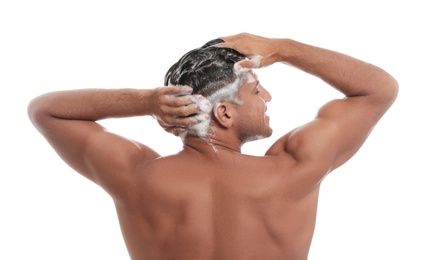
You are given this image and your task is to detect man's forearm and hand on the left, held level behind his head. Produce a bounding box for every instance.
[28,86,203,137]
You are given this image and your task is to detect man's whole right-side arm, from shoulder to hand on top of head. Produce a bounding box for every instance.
[220,34,398,179]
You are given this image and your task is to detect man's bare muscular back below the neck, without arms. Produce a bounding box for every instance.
[117,148,318,259]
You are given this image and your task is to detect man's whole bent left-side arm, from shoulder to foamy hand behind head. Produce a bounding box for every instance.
[28,86,204,196]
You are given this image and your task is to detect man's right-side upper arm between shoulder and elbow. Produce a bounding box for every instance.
[285,96,383,171]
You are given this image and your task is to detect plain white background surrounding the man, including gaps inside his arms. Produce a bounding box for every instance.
[0,0,432,260]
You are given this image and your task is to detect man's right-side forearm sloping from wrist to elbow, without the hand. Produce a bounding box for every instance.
[274,39,397,97]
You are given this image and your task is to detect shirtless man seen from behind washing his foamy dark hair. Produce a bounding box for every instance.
[29,34,398,259]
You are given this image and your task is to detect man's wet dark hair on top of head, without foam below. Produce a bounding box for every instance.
[164,39,246,97]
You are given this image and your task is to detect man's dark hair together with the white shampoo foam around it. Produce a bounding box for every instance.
[164,39,246,138]
